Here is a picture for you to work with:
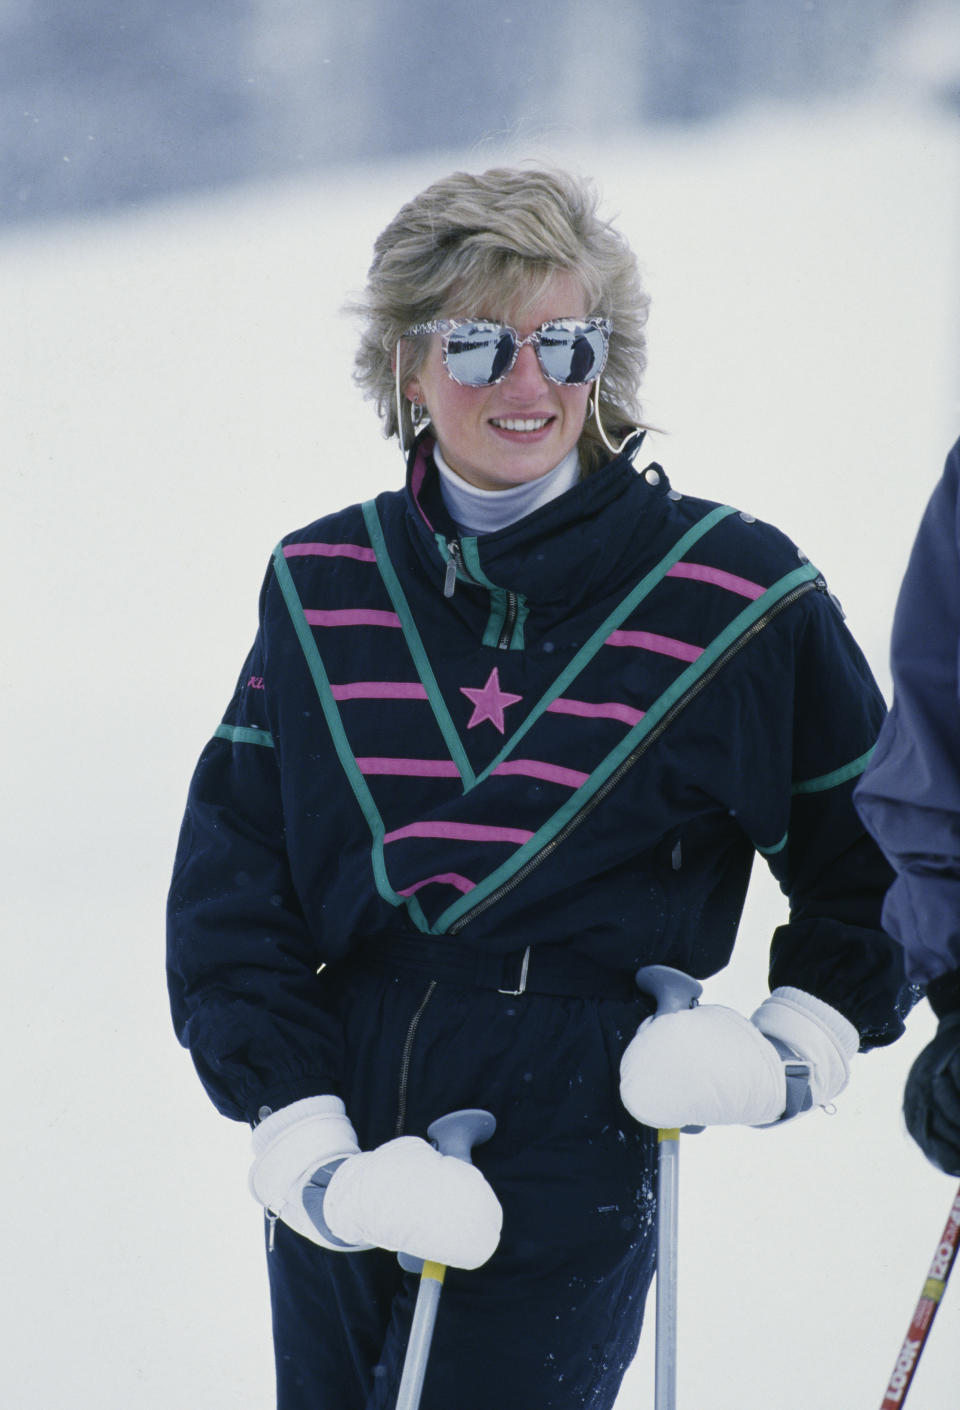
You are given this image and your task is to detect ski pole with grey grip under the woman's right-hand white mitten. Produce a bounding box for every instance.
[634,964,703,1410]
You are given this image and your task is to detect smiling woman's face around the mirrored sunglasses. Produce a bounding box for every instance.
[406,271,593,489]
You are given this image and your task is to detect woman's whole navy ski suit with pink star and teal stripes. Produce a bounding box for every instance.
[169,437,905,1410]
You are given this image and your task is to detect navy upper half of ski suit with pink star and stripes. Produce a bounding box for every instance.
[169,437,904,1120]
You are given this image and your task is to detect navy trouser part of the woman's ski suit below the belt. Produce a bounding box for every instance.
[260,971,657,1410]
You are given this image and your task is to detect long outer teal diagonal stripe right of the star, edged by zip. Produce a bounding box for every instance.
[431,563,819,933]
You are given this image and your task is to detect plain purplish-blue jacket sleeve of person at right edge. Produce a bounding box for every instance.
[857,441,960,1007]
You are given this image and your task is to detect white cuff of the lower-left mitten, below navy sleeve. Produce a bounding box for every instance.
[250,1097,371,1249]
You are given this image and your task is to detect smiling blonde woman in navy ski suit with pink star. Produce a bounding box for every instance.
[169,169,904,1410]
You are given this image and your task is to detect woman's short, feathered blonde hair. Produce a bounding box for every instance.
[350,166,650,470]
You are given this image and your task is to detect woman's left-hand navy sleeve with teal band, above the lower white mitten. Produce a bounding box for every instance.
[166,566,341,1121]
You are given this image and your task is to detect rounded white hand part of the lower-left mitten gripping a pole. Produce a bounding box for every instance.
[323,1136,503,1268]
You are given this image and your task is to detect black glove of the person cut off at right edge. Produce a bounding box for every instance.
[904,971,960,1175]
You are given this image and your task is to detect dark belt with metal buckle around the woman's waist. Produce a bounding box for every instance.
[347,935,653,1012]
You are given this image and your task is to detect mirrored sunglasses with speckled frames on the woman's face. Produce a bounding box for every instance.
[403,319,612,386]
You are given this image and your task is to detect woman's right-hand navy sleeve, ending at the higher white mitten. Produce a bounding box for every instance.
[740,592,916,1050]
